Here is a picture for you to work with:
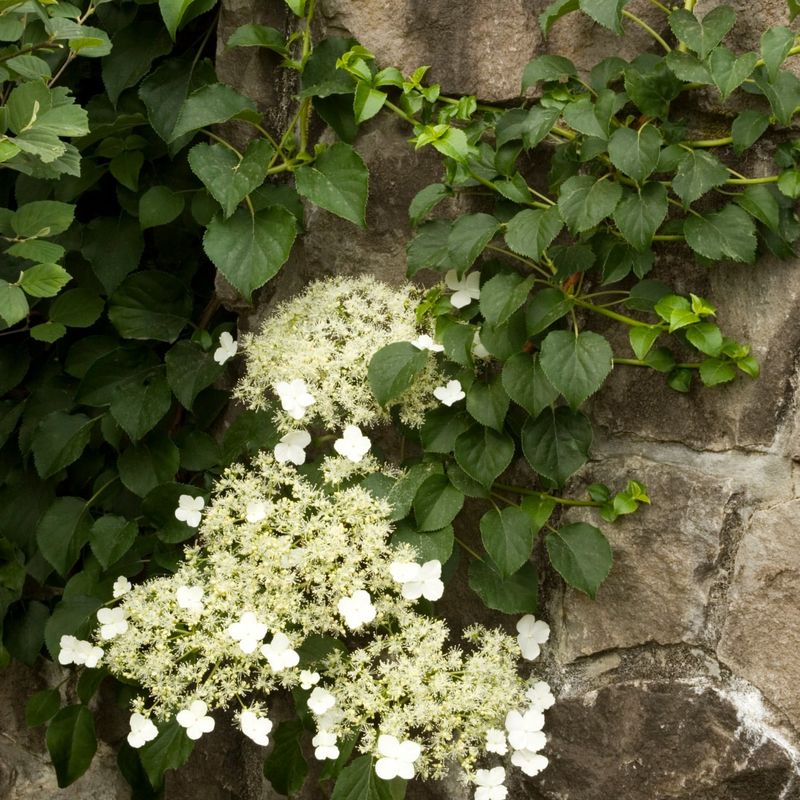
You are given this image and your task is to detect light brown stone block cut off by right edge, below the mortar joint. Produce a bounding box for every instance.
[718,500,800,728]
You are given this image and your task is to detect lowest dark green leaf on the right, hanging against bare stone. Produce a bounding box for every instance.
[544,522,614,599]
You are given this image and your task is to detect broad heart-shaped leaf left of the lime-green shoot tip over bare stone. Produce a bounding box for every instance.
[541,331,614,409]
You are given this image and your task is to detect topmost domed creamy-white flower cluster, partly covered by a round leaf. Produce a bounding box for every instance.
[235,276,442,432]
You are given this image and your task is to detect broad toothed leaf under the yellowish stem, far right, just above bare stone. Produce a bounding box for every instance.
[683,203,756,264]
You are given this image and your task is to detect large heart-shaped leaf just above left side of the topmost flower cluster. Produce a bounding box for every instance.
[203,206,297,300]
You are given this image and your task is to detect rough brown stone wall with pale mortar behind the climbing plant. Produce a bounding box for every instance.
[0,0,800,800]
